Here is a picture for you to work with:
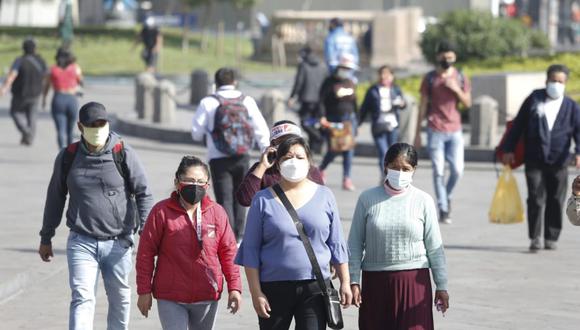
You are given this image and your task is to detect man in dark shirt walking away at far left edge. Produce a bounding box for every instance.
[0,39,46,146]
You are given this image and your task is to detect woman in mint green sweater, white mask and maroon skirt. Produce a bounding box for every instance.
[348,143,449,330]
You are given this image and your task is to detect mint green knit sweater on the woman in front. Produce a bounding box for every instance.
[348,186,447,290]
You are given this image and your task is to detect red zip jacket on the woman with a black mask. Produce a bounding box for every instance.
[136,192,242,303]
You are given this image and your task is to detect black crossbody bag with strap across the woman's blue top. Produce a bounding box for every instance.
[272,184,344,329]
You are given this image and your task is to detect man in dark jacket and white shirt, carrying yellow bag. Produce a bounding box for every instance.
[502,64,580,252]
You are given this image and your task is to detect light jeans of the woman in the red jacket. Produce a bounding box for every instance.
[157,299,218,330]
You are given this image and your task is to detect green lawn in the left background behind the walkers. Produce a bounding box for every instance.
[0,27,284,76]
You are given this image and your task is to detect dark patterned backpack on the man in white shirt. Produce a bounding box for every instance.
[211,94,254,156]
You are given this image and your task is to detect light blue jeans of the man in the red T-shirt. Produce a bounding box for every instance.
[427,128,464,212]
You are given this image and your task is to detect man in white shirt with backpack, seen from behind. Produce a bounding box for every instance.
[191,68,270,242]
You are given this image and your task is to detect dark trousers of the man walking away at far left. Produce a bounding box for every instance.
[10,97,40,144]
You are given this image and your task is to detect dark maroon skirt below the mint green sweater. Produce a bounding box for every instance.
[358,269,433,330]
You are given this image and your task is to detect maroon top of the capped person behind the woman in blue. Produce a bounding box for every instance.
[236,162,324,206]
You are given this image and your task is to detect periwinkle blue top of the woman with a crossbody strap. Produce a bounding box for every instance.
[235,185,348,282]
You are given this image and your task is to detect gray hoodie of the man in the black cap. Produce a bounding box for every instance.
[40,133,153,244]
